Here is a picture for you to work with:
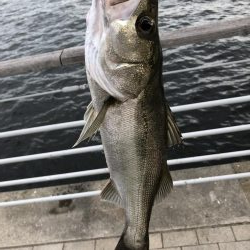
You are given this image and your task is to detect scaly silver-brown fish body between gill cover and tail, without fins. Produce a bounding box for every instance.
[101,86,166,244]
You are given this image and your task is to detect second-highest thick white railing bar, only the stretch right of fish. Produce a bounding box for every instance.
[182,124,250,139]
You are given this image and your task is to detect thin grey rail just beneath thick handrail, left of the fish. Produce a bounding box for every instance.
[0,84,88,103]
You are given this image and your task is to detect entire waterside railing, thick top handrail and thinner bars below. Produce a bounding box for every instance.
[0,17,250,207]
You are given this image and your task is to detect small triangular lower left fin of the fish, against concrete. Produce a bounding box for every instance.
[101,179,122,207]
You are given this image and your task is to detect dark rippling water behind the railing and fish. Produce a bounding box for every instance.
[0,0,250,188]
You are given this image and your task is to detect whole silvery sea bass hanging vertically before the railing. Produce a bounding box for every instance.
[76,0,182,250]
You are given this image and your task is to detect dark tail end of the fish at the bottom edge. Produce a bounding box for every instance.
[115,230,149,250]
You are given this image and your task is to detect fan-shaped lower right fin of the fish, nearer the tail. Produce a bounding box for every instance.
[155,166,173,204]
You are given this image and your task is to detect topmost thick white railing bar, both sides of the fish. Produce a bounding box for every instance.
[0,95,250,139]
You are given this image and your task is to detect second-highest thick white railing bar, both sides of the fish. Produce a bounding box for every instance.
[0,124,250,165]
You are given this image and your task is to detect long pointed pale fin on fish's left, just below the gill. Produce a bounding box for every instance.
[73,97,114,147]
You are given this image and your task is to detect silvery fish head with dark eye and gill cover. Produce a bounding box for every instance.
[87,0,162,101]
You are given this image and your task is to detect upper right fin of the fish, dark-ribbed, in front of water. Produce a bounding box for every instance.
[166,104,182,147]
